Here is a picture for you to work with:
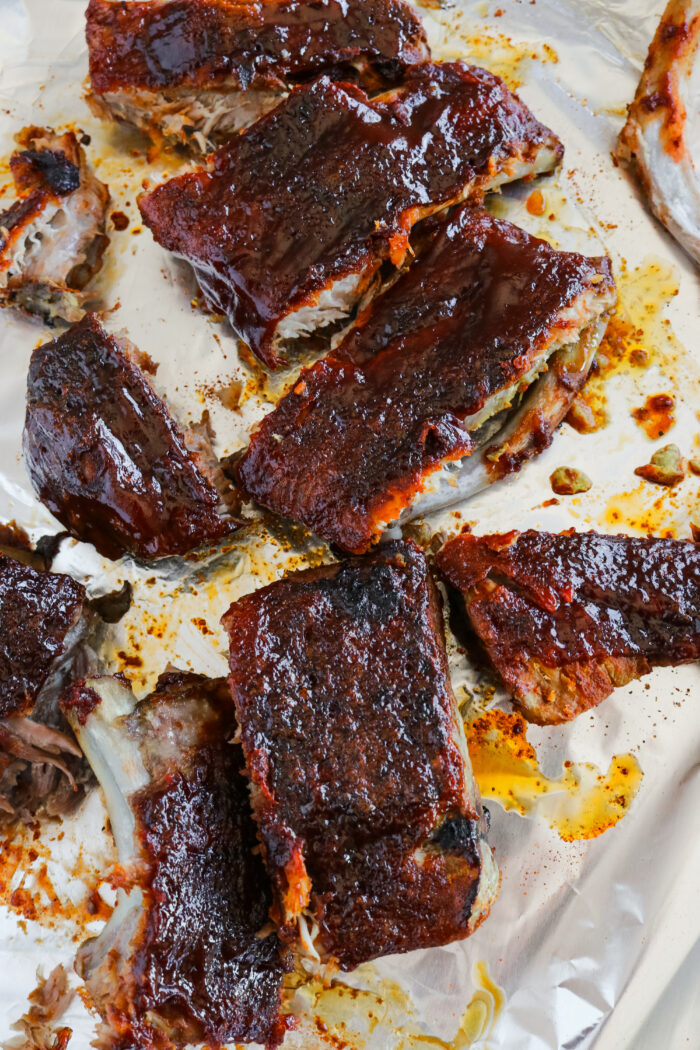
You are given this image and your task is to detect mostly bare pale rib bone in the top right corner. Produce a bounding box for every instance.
[617,0,700,261]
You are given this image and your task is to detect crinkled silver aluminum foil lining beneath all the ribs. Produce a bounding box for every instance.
[0,0,700,1050]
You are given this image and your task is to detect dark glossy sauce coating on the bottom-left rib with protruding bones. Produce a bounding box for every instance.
[132,675,284,1046]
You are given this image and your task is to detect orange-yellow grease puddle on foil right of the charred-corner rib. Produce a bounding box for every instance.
[465,708,642,842]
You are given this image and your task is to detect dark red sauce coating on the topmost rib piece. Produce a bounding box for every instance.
[86,0,430,93]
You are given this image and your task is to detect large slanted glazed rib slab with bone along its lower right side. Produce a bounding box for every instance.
[237,206,615,553]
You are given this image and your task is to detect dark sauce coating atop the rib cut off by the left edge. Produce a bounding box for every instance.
[0,554,85,718]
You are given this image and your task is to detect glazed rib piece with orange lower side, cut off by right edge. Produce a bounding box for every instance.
[436,530,700,725]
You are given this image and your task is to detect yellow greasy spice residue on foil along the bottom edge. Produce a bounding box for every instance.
[290,961,505,1050]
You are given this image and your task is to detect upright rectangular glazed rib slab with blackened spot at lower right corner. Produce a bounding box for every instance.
[224,543,499,968]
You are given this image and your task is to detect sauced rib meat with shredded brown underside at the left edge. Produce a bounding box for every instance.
[0,554,89,823]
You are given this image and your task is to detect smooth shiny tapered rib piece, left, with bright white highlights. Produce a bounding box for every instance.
[24,314,239,559]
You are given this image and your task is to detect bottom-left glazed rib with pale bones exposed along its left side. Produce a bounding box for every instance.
[62,672,285,1050]
